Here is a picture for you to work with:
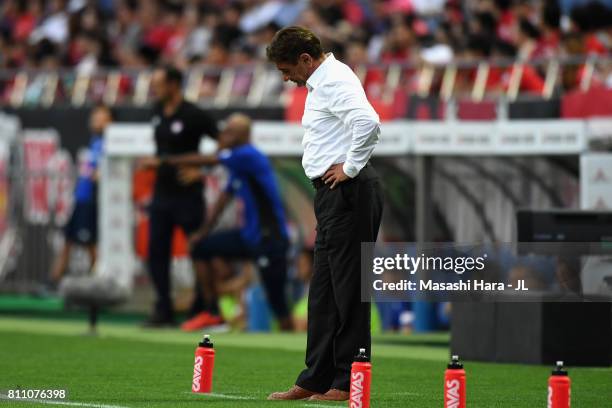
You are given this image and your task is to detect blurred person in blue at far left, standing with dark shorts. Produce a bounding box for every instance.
[51,105,113,283]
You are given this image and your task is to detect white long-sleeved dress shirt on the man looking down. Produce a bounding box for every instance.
[302,54,380,179]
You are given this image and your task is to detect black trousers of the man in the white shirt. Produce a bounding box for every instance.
[296,165,383,392]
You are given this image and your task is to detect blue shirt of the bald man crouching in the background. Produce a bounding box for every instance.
[218,144,288,245]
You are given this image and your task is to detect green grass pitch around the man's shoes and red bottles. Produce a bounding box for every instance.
[0,316,612,408]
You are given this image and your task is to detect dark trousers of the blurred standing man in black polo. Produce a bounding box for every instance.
[148,192,205,317]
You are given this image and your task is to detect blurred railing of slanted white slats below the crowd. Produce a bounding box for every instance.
[0,56,612,108]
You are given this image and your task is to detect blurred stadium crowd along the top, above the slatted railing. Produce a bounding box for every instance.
[0,0,612,72]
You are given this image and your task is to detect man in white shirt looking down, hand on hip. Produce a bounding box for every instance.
[267,27,383,401]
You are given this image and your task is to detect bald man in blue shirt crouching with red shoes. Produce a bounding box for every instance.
[170,114,293,331]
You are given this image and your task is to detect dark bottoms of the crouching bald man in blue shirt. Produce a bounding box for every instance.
[191,229,289,319]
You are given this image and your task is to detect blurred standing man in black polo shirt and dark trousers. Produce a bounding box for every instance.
[141,66,217,327]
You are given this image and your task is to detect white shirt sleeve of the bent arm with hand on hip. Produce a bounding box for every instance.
[325,81,380,178]
